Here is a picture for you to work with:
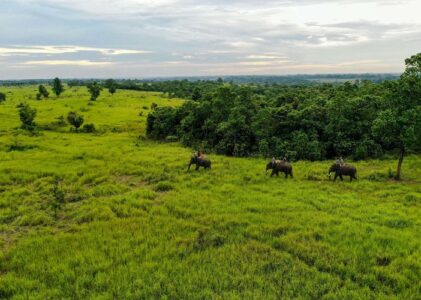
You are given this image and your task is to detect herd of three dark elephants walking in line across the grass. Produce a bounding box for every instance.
[187,154,357,181]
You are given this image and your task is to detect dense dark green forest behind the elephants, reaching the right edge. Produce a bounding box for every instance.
[144,54,421,178]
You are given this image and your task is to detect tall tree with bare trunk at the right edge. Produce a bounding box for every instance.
[372,53,421,180]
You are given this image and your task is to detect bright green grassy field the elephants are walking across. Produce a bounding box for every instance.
[0,86,421,299]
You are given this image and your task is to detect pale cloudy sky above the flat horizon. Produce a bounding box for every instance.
[0,0,421,79]
